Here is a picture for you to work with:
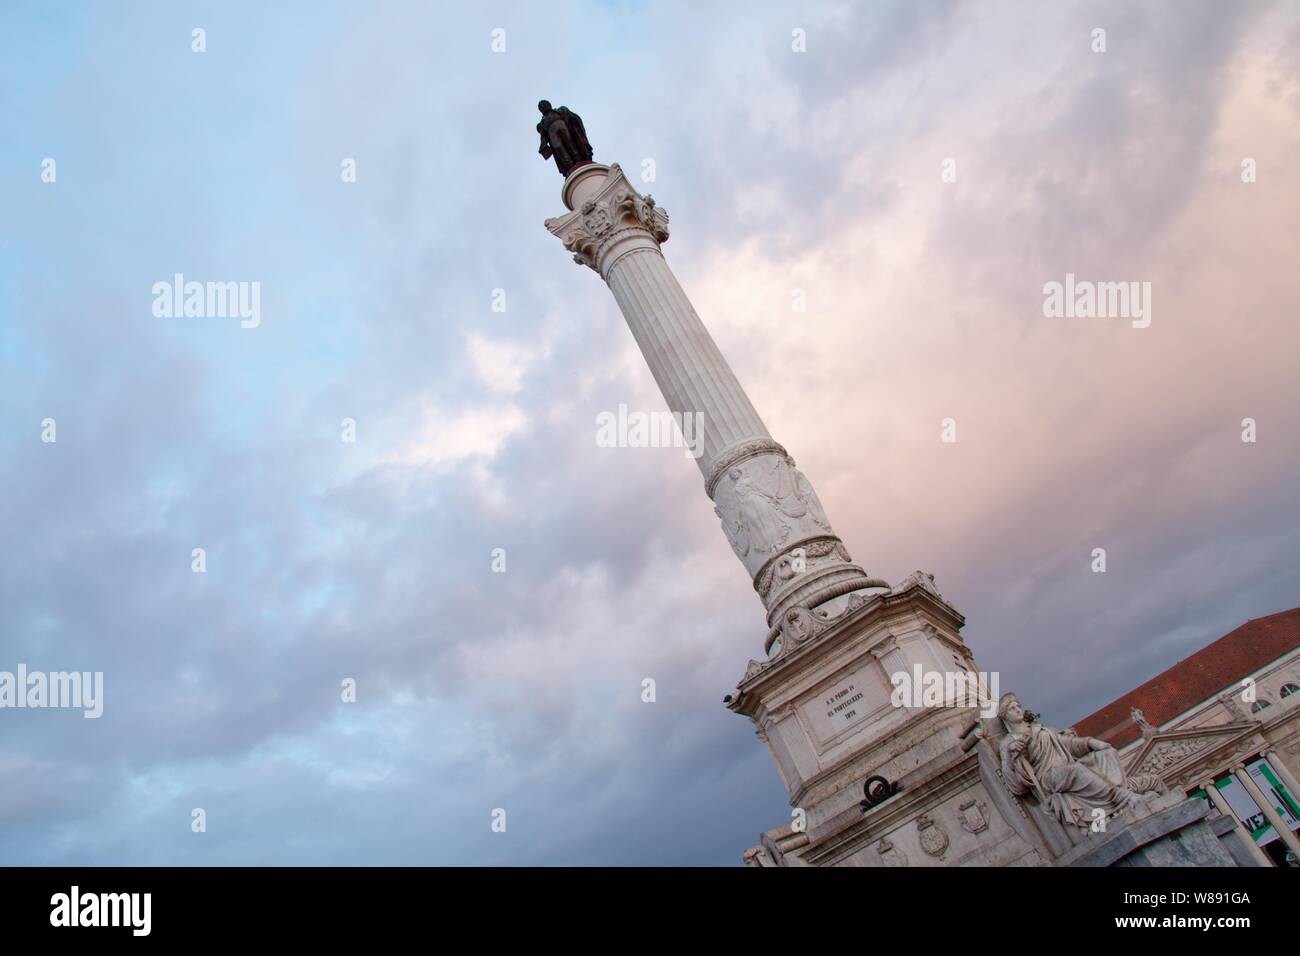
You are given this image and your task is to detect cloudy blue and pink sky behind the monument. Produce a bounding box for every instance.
[0,0,1300,865]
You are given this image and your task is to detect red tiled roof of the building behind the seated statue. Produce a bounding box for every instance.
[1074,607,1300,747]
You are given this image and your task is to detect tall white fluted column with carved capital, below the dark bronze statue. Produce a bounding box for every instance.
[546,163,884,626]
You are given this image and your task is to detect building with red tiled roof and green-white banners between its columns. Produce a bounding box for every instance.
[1074,607,1300,865]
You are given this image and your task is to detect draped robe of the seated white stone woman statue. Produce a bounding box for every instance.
[1000,723,1161,827]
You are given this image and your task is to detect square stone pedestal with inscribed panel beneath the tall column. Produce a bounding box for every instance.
[727,571,1044,866]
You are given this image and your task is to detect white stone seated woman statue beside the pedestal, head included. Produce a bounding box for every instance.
[997,693,1165,830]
